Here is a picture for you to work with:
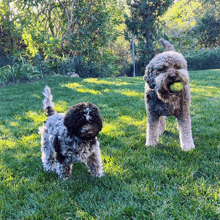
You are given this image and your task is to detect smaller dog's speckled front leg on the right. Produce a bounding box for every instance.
[85,141,104,177]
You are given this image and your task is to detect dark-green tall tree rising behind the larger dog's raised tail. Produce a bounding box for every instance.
[125,0,173,70]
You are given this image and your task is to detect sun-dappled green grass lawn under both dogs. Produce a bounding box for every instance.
[0,70,220,220]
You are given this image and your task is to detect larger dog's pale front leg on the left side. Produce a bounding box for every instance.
[146,114,159,146]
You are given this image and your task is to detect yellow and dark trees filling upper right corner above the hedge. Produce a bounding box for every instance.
[160,0,220,53]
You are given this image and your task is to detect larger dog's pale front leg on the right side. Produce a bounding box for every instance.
[177,112,195,151]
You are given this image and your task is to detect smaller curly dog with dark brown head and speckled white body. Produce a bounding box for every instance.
[40,86,104,179]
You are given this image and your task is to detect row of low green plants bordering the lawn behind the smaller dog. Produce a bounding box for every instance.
[0,52,119,84]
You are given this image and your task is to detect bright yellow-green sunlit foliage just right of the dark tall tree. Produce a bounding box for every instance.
[160,0,202,55]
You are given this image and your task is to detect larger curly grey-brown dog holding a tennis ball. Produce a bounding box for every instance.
[144,39,195,151]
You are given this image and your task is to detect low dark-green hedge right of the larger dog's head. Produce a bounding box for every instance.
[186,47,220,70]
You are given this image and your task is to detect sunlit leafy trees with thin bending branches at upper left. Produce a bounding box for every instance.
[0,0,123,77]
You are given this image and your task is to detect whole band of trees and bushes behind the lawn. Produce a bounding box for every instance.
[0,0,220,83]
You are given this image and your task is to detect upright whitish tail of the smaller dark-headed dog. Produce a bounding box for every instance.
[42,86,56,117]
